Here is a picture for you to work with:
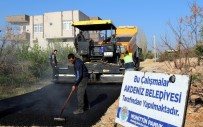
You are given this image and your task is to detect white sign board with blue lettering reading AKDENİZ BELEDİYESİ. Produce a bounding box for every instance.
[115,71,190,127]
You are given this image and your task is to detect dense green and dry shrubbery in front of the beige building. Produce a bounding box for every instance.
[0,39,74,85]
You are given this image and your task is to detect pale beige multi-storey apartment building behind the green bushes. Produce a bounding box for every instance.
[6,10,92,48]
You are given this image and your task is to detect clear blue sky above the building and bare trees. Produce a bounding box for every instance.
[0,0,203,48]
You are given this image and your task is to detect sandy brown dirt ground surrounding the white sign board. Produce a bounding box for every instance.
[93,59,203,127]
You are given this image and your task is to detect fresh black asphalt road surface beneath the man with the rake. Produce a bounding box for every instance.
[0,84,121,127]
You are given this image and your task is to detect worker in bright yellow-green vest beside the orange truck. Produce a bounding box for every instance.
[124,51,135,71]
